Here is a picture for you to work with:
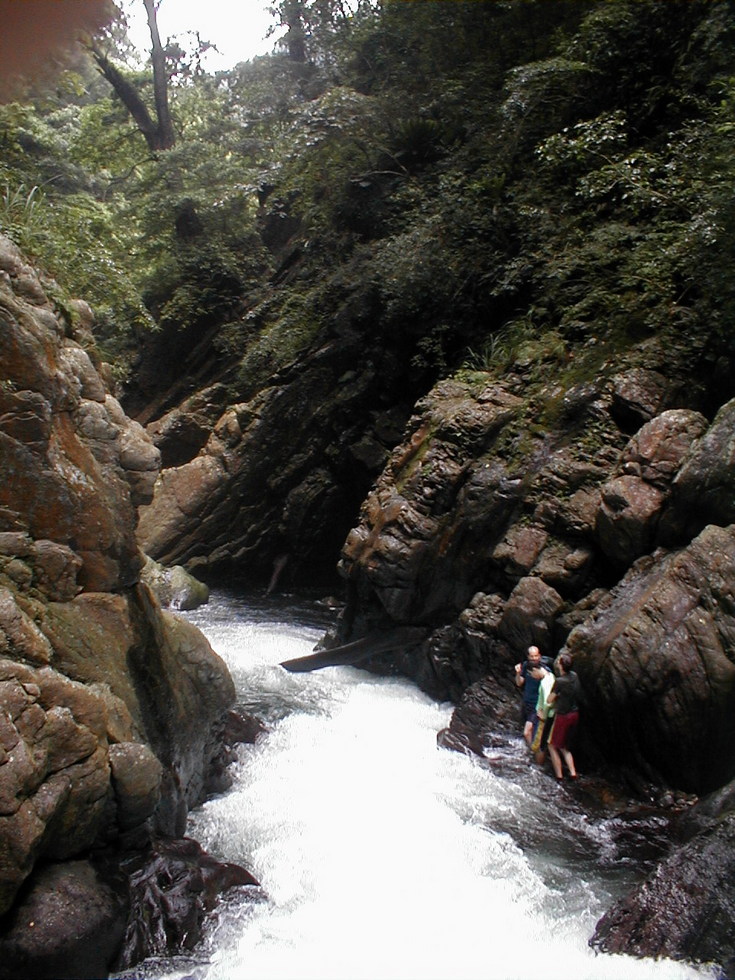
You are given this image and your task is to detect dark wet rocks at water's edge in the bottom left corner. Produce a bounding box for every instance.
[0,838,258,980]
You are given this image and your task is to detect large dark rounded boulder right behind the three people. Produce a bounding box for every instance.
[567,526,735,793]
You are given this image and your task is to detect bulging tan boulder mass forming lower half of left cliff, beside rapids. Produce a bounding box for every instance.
[0,576,235,911]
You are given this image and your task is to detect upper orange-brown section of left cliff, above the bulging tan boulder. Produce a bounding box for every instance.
[0,249,160,592]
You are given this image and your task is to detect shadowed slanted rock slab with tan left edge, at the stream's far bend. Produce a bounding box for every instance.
[138,306,411,582]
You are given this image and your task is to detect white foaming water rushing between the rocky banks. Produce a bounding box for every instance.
[118,595,709,980]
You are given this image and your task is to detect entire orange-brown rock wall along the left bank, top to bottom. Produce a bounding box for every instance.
[0,239,247,976]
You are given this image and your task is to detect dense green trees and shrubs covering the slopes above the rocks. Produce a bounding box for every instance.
[0,0,735,402]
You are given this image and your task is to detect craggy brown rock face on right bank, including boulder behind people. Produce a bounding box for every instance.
[325,341,735,793]
